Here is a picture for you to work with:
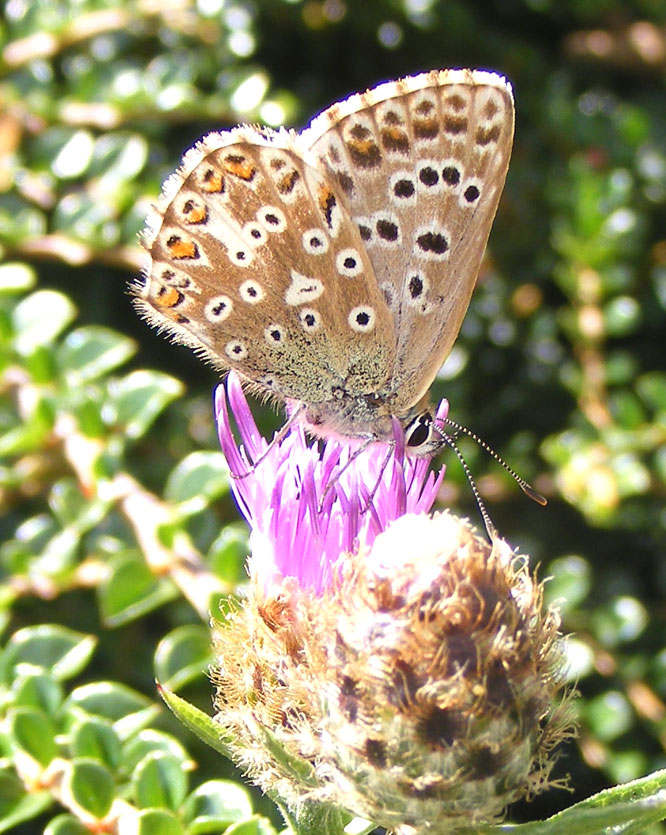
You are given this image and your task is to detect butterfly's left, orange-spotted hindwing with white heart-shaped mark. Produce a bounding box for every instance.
[135,128,395,404]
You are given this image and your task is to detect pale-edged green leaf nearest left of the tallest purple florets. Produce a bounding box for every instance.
[109,370,183,438]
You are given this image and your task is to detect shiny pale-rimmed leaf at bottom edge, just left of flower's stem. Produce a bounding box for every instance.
[182,780,252,835]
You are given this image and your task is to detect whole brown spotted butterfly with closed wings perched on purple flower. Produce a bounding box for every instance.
[133,70,514,455]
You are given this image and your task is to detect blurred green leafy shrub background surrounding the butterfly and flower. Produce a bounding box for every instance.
[0,0,666,835]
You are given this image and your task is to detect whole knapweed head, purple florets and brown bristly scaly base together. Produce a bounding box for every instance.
[215,376,569,835]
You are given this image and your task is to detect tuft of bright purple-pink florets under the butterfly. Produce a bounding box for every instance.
[215,372,448,593]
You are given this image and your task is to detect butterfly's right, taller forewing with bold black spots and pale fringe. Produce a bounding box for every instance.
[300,70,514,414]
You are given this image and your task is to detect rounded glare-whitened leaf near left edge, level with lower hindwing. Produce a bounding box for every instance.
[12,290,76,356]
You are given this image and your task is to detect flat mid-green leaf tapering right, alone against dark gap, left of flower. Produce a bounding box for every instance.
[98,553,178,626]
